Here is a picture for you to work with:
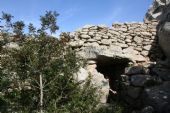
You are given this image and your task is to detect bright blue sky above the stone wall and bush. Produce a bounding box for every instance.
[0,0,153,33]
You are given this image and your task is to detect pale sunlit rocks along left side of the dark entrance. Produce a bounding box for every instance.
[74,65,110,104]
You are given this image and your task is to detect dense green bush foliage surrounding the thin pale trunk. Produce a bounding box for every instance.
[0,38,98,113]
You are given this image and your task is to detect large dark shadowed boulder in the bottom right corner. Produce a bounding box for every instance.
[142,81,170,113]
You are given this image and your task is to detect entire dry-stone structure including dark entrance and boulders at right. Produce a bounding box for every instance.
[61,0,170,113]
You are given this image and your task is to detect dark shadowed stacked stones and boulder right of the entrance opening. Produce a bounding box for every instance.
[121,66,170,113]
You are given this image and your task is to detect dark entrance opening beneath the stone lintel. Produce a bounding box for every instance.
[96,56,130,103]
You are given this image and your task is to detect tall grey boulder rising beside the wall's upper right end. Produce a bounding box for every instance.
[145,0,170,67]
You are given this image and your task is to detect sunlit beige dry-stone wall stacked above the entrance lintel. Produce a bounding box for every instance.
[70,21,157,62]
